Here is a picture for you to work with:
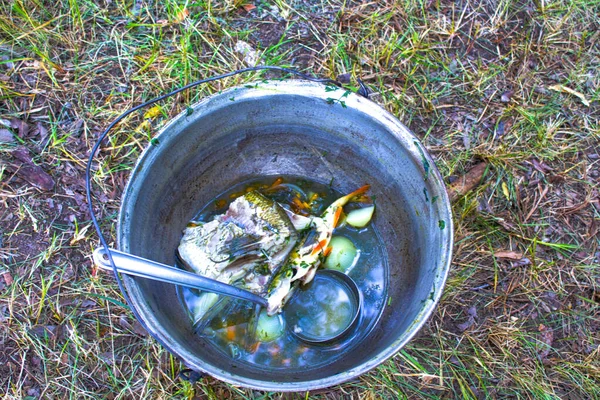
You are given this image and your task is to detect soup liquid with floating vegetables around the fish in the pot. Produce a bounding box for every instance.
[178,176,388,372]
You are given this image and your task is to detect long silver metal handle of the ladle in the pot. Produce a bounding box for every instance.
[94,247,267,307]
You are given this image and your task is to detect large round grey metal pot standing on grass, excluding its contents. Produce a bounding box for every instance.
[118,80,453,391]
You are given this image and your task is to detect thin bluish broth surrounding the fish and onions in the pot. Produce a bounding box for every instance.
[178,176,389,371]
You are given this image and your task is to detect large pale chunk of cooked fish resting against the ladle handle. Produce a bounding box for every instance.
[178,191,298,318]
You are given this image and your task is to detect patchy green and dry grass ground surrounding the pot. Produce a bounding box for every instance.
[0,0,600,399]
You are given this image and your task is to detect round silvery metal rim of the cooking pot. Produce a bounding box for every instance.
[117,79,454,392]
